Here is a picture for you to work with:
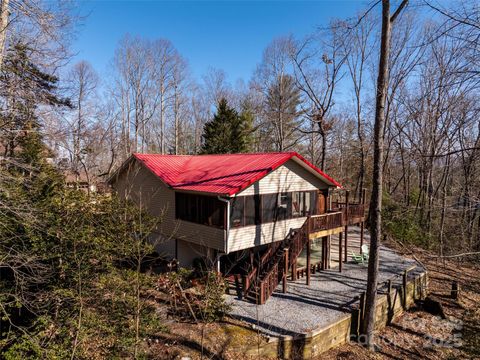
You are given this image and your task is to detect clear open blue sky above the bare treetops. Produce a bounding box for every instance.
[74,0,368,82]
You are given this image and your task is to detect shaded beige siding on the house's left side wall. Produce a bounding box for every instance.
[114,162,225,256]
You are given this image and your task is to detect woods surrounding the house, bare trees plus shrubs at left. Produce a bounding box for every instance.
[0,0,480,359]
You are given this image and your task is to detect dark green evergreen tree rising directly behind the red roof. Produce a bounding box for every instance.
[201,99,253,154]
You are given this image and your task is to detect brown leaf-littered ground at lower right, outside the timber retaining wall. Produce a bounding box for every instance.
[321,243,480,360]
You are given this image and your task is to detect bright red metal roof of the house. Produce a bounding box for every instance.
[133,152,341,195]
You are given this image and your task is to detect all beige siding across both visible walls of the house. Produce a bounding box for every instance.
[115,160,328,256]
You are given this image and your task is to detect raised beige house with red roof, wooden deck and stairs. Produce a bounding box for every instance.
[109,152,363,301]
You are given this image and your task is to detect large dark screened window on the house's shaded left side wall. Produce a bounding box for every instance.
[175,193,225,228]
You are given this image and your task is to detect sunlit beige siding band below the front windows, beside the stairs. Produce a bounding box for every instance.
[227,217,306,252]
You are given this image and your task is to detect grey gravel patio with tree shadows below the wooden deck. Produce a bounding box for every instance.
[227,227,424,336]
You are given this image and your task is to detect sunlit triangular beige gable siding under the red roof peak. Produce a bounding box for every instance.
[237,160,328,196]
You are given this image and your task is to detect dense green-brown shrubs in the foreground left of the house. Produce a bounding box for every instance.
[0,154,165,359]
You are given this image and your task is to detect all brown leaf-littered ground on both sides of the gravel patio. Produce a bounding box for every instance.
[146,240,480,360]
